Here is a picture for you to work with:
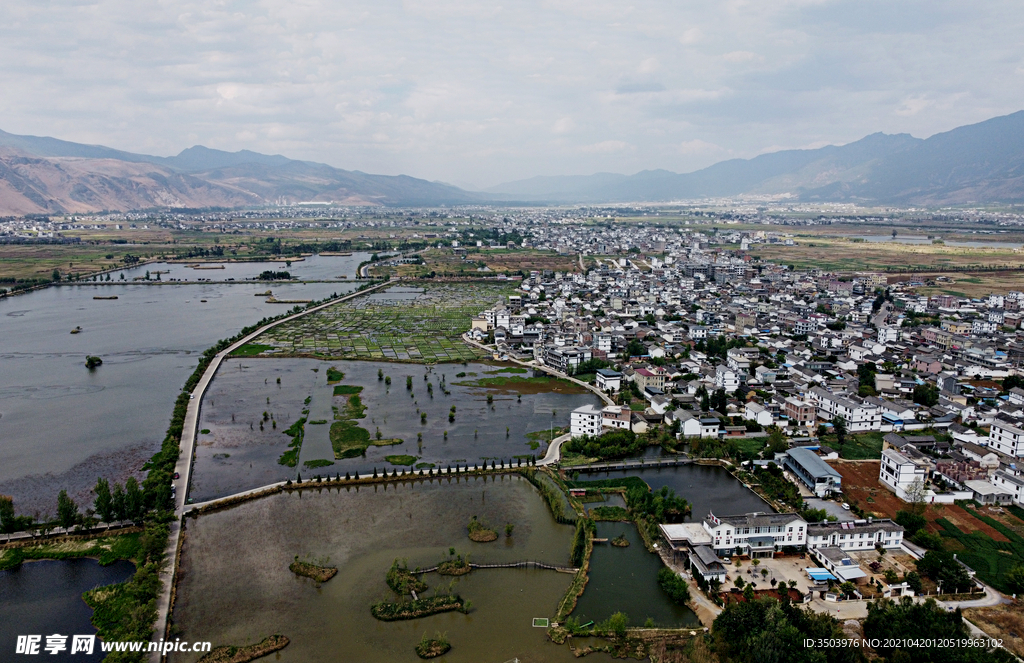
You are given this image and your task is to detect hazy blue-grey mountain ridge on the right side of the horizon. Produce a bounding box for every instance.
[484,111,1024,205]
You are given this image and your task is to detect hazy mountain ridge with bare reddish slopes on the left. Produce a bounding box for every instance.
[0,131,480,215]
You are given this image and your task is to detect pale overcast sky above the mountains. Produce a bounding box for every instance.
[0,0,1024,188]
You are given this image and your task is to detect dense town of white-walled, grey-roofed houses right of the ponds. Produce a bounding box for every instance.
[458,223,1024,518]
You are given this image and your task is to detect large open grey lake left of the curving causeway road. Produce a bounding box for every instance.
[0,256,358,514]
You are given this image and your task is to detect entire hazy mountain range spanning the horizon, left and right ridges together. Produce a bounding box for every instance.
[0,111,1024,215]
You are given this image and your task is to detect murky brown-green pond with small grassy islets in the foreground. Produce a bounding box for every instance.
[171,476,610,663]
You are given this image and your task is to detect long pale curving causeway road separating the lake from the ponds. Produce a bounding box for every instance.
[150,281,392,663]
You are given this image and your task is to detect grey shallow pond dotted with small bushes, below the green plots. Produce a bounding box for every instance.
[189,358,600,502]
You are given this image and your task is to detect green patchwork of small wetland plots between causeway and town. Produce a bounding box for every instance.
[254,283,513,364]
